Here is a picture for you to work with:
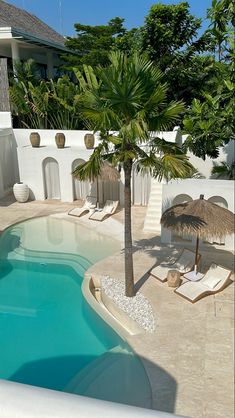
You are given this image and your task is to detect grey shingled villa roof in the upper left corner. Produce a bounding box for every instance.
[0,0,64,48]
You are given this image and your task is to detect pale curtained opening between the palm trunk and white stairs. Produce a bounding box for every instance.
[132,164,151,206]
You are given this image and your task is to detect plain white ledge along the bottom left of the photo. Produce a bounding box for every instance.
[0,380,187,418]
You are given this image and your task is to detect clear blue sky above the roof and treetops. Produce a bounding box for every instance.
[5,0,212,36]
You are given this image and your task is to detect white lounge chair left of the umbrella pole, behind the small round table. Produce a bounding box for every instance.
[150,248,198,282]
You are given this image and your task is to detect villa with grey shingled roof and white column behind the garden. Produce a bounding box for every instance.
[0,0,67,78]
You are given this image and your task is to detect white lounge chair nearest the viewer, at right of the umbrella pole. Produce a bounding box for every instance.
[175,263,232,303]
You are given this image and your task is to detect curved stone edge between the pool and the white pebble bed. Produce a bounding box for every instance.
[82,273,153,409]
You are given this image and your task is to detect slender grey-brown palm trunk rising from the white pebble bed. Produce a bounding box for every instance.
[124,160,135,297]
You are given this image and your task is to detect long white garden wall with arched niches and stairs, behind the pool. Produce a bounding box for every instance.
[0,112,234,249]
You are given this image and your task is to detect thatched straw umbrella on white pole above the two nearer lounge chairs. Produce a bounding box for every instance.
[161,195,234,272]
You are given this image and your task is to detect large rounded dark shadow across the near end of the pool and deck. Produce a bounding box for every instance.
[9,352,177,412]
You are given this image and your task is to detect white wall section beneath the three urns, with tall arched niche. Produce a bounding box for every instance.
[14,129,101,202]
